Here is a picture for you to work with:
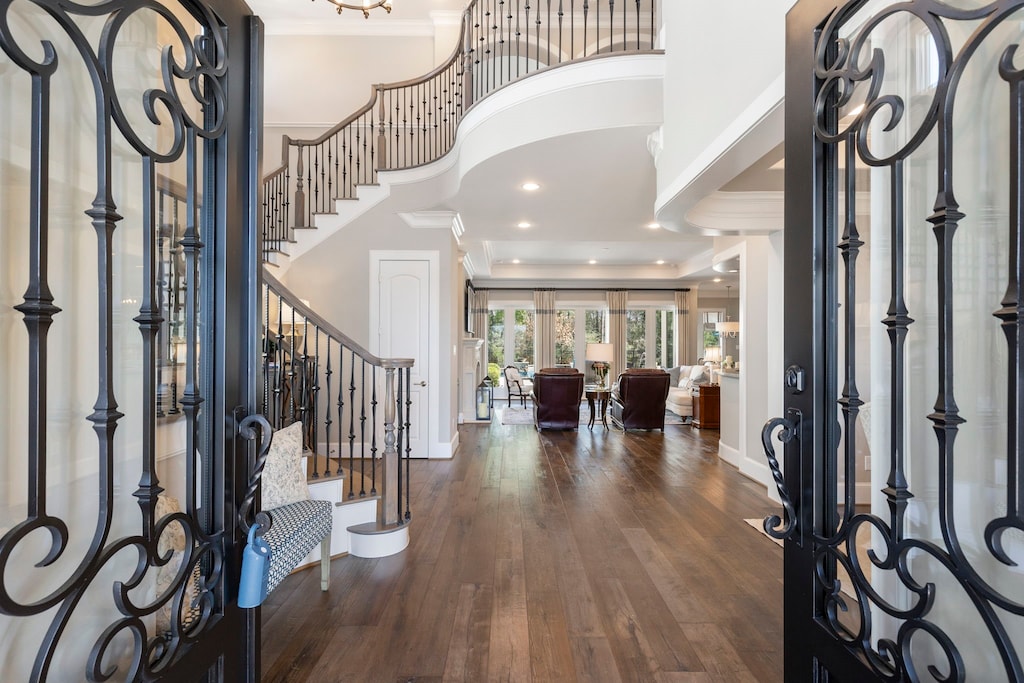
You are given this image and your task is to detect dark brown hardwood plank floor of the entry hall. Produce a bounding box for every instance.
[262,424,782,683]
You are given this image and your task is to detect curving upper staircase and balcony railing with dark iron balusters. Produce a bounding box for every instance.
[263,0,657,251]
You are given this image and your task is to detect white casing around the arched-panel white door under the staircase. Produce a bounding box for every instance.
[368,249,438,458]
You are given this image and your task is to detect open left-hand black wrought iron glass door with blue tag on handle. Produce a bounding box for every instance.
[0,0,260,681]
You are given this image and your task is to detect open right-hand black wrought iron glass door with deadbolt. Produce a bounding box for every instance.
[765,0,1024,681]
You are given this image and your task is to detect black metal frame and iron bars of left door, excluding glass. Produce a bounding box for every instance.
[0,0,262,671]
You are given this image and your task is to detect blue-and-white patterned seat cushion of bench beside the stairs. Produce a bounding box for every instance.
[263,501,333,593]
